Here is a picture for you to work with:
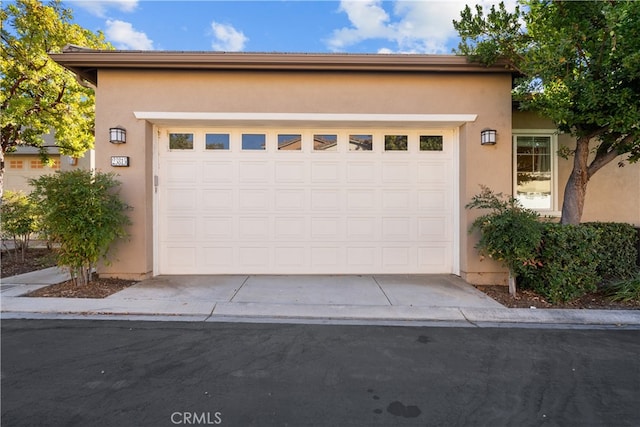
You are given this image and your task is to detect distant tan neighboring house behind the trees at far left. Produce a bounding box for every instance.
[3,134,93,194]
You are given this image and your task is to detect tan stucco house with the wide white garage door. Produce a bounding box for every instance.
[52,49,640,283]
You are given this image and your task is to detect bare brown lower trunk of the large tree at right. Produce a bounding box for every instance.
[560,137,589,225]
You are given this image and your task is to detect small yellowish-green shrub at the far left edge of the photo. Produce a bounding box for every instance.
[0,191,38,262]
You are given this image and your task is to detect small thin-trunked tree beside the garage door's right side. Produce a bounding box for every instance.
[466,186,542,296]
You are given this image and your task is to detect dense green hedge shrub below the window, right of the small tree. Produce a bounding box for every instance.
[524,223,600,303]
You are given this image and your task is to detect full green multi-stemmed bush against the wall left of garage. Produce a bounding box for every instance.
[31,170,130,284]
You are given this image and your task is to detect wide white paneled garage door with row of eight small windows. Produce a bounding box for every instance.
[155,128,455,274]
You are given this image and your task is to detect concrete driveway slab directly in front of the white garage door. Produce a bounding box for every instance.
[109,275,502,308]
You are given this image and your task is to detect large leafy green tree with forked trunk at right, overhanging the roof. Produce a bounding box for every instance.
[453,0,640,224]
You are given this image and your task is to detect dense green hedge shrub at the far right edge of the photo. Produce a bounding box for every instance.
[582,222,638,281]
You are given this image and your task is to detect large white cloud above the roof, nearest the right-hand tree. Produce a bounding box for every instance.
[327,0,515,53]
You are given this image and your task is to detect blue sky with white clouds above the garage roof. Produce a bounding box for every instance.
[63,0,512,53]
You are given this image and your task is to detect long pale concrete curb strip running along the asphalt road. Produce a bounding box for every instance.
[0,298,640,329]
